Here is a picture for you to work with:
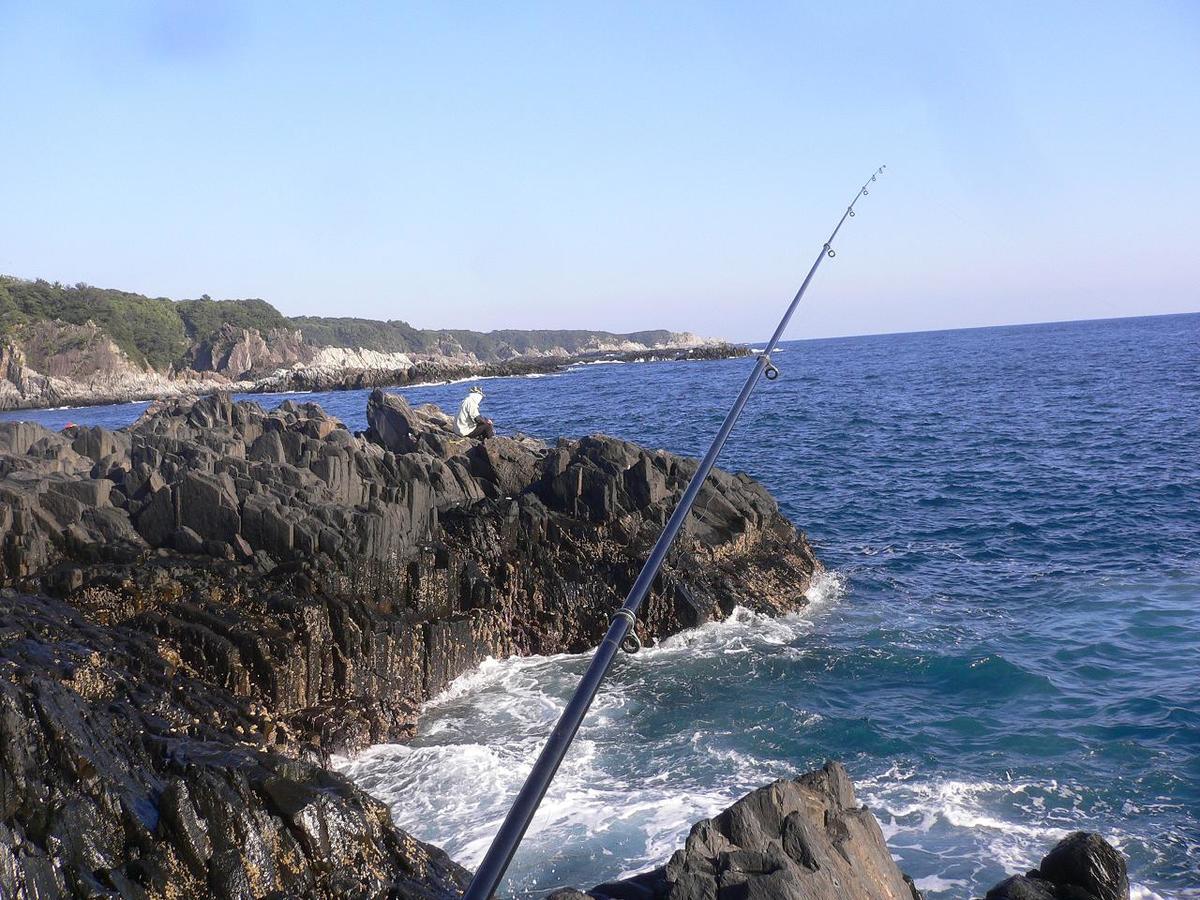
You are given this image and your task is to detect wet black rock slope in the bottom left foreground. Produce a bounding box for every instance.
[0,595,466,900]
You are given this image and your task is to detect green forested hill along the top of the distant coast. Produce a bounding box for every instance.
[0,276,698,372]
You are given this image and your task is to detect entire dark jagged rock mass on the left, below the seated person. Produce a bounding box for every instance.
[0,391,817,898]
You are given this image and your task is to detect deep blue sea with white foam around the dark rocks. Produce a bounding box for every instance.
[6,314,1200,898]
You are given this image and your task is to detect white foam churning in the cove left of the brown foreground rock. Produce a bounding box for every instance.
[334,585,845,877]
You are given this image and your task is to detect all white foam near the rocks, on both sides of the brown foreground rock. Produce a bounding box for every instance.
[335,571,1176,900]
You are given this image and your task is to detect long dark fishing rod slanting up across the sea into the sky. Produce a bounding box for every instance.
[463,166,887,900]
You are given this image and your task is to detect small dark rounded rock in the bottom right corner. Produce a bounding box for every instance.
[986,832,1129,900]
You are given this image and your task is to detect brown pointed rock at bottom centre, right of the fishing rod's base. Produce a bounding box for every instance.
[571,763,920,900]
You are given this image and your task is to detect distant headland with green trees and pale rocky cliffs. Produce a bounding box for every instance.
[0,276,748,409]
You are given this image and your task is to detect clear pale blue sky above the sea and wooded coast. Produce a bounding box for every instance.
[0,0,1200,340]
